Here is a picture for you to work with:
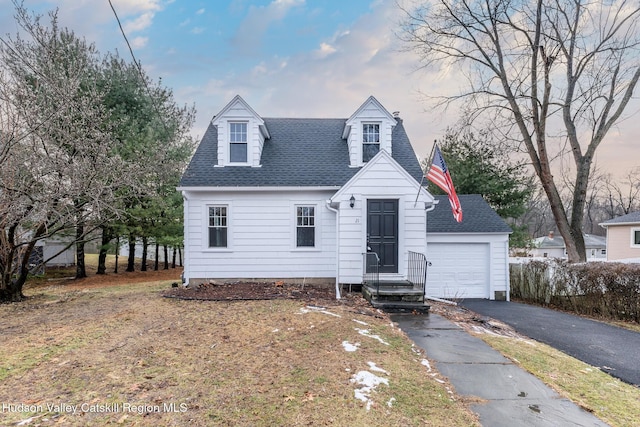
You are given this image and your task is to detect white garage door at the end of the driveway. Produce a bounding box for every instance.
[427,243,489,299]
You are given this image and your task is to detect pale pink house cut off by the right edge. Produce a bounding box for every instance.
[600,211,640,262]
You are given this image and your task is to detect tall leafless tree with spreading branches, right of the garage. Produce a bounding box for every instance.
[402,0,640,261]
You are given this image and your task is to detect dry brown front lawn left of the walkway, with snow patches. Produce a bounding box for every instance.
[0,270,478,426]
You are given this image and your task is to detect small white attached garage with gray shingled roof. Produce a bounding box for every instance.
[426,194,511,300]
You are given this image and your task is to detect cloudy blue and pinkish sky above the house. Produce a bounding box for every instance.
[0,0,640,173]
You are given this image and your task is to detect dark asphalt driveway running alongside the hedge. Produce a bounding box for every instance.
[460,299,640,386]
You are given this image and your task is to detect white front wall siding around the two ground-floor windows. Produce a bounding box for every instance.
[185,191,336,280]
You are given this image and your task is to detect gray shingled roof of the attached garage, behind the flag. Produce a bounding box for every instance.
[427,194,512,233]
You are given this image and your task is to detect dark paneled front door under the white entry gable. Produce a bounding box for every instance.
[367,200,398,273]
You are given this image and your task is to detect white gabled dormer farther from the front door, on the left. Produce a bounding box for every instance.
[211,95,270,167]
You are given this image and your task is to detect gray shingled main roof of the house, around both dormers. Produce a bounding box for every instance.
[180,118,422,187]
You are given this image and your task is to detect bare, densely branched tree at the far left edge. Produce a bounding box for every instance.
[0,6,123,301]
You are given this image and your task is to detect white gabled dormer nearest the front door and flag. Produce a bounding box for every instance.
[342,96,397,167]
